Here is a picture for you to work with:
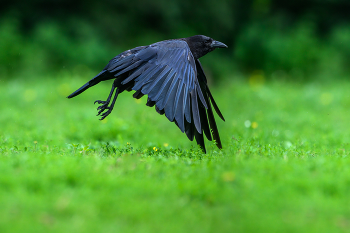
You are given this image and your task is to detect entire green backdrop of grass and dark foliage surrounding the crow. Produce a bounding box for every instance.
[0,0,350,233]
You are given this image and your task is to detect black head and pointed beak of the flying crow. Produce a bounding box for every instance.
[185,35,227,59]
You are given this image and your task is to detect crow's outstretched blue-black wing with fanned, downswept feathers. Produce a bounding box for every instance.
[105,40,221,150]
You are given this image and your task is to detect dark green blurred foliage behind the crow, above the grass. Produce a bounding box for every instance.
[0,0,350,81]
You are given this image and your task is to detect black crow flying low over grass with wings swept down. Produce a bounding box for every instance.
[68,35,227,152]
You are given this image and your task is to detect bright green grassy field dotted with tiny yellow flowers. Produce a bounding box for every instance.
[0,74,350,233]
